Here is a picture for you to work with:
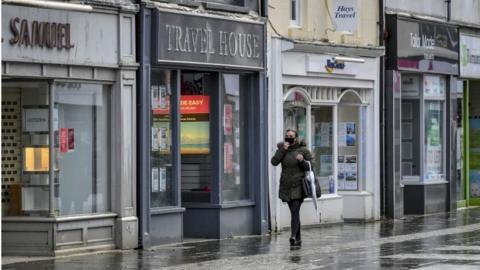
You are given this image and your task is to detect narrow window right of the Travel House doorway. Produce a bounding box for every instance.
[221,74,249,201]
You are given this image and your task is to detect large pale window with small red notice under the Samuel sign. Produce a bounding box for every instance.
[55,83,111,215]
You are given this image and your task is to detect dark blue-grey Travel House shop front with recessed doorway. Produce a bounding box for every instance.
[137,4,268,247]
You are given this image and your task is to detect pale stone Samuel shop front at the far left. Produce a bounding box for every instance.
[2,1,138,256]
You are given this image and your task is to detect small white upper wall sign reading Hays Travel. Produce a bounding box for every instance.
[331,0,358,32]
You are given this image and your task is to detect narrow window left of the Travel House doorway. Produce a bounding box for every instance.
[150,70,176,207]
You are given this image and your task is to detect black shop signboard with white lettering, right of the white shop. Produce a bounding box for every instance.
[387,15,459,75]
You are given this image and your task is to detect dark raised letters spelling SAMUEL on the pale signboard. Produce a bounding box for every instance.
[10,17,75,50]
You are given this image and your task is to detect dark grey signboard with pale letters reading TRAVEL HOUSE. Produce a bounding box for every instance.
[157,10,264,69]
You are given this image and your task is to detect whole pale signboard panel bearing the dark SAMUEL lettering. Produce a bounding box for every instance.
[2,4,119,67]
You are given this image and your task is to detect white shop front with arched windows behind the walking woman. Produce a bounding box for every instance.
[269,38,383,230]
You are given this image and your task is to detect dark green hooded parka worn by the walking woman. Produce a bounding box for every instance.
[271,141,312,202]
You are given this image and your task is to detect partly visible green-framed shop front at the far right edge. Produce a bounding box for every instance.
[457,29,480,207]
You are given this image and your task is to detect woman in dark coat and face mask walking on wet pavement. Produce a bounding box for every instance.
[271,129,312,246]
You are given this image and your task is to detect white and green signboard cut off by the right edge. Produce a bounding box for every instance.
[460,33,480,78]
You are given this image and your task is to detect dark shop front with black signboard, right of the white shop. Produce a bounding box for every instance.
[384,15,459,218]
